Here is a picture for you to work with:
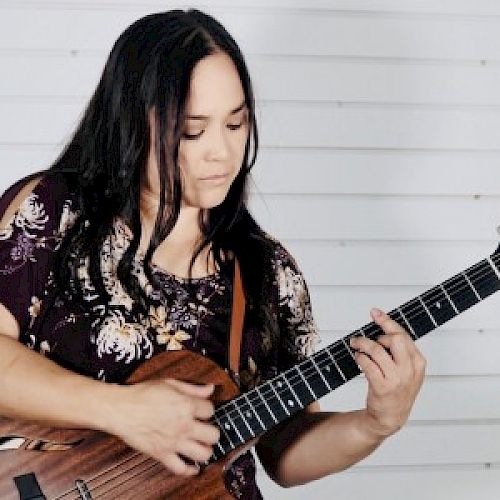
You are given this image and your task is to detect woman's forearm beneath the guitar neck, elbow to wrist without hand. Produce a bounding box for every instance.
[259,410,384,487]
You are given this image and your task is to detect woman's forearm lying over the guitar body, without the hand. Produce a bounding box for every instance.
[0,334,117,430]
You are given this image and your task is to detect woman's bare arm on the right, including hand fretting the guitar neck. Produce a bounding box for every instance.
[256,309,426,487]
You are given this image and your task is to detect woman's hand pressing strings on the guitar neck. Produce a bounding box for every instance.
[351,309,426,438]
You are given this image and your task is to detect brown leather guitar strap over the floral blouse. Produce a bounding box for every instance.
[229,257,245,386]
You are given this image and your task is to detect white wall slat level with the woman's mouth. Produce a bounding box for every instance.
[0,145,500,196]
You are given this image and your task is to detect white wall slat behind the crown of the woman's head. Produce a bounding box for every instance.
[0,10,500,59]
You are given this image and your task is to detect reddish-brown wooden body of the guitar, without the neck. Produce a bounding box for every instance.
[0,350,251,500]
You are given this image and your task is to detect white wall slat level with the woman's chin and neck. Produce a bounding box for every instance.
[250,195,500,241]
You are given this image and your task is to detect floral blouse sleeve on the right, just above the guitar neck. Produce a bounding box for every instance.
[275,244,319,371]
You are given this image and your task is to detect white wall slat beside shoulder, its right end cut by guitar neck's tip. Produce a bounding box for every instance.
[285,240,497,291]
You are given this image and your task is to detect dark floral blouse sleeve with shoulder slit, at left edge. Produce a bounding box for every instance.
[0,178,75,334]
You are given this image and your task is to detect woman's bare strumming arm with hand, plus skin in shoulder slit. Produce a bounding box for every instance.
[0,180,219,475]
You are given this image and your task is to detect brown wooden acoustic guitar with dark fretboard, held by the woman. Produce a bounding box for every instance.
[0,249,500,500]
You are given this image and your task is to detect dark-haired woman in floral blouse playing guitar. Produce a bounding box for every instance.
[0,10,425,498]
